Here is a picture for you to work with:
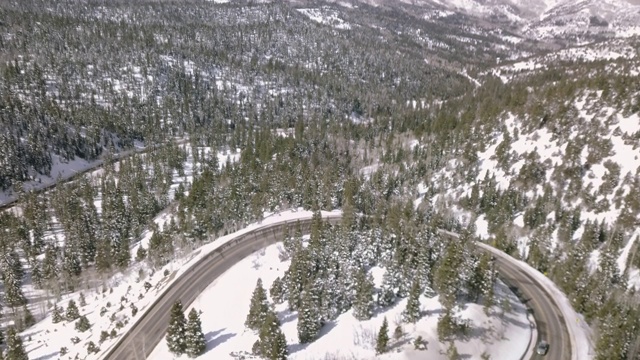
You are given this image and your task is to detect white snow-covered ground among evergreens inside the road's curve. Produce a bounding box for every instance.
[149,244,531,360]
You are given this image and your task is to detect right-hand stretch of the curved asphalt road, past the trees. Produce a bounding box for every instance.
[483,246,571,360]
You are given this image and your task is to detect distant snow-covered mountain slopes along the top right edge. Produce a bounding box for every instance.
[332,0,640,43]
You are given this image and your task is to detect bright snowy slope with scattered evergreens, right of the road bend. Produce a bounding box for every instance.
[421,48,640,288]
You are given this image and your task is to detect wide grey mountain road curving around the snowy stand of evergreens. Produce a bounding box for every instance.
[100,214,571,360]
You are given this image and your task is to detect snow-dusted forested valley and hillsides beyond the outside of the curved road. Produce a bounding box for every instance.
[0,0,640,360]
